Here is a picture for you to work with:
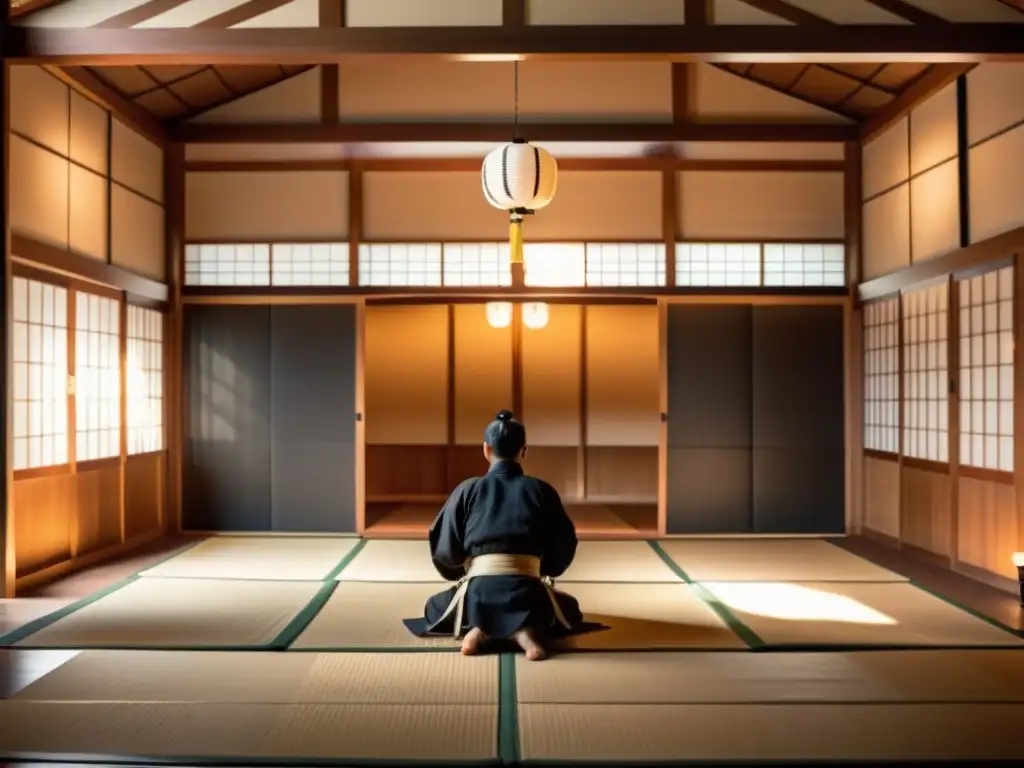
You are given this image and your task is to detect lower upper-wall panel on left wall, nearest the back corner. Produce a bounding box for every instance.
[111,184,167,281]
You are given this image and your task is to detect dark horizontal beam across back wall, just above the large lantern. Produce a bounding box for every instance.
[171,122,860,144]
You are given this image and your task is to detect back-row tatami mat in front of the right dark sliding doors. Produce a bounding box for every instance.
[658,539,907,582]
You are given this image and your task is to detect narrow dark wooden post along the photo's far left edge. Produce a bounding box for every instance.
[0,2,15,597]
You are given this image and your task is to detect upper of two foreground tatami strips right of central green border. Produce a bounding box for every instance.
[516,651,1024,705]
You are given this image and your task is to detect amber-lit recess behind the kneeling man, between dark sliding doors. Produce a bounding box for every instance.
[365,303,660,538]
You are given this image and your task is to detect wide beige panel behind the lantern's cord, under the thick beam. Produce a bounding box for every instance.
[338,59,672,121]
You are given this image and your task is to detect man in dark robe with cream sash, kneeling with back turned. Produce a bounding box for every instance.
[407,411,587,658]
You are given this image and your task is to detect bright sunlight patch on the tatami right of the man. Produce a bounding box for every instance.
[705,582,896,625]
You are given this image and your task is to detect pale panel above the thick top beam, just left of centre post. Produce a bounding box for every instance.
[339,0,502,27]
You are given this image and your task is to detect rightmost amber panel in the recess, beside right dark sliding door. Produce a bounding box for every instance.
[586,305,662,446]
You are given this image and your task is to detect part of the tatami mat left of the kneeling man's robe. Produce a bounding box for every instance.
[291,582,456,649]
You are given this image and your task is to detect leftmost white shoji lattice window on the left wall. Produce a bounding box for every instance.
[11,278,69,471]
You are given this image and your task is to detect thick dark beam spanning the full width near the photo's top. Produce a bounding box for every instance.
[3,24,1024,66]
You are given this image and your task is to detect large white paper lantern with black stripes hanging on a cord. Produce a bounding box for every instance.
[481,139,558,214]
